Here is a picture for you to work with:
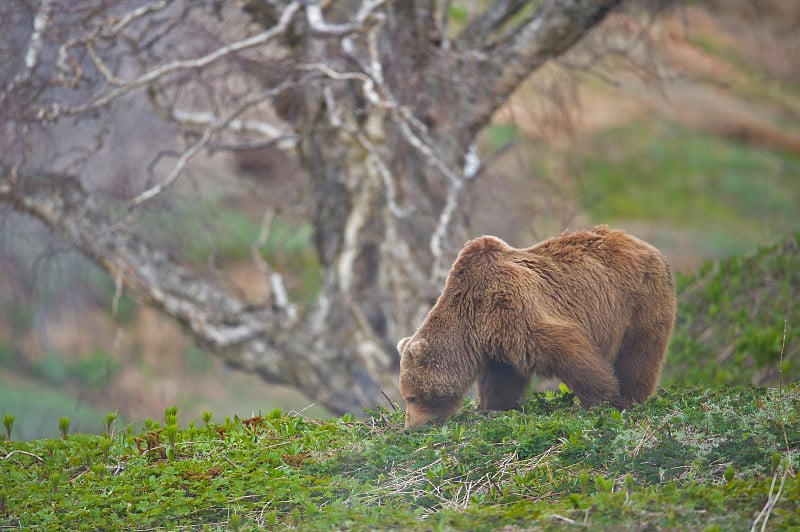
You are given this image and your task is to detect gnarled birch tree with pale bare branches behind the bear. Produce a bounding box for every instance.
[0,0,620,412]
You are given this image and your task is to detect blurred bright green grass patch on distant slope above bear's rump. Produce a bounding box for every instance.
[577,122,800,256]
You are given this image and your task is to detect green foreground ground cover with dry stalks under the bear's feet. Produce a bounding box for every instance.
[0,385,800,530]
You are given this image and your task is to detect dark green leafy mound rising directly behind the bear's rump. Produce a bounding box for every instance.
[662,233,800,386]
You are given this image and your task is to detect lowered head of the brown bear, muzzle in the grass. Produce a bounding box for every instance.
[397,337,465,430]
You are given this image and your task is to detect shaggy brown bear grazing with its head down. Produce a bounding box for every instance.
[397,227,675,428]
